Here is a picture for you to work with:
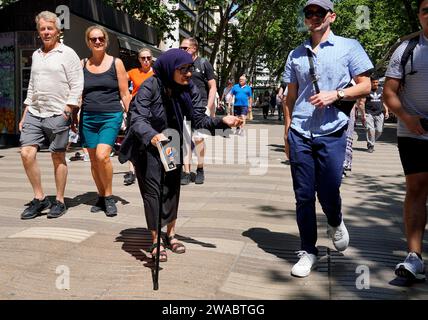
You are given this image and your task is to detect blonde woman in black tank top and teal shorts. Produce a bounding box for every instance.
[80,26,131,217]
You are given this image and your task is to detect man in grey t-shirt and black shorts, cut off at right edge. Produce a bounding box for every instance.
[383,0,428,280]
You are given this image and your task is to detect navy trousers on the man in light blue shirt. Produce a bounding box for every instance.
[288,126,347,255]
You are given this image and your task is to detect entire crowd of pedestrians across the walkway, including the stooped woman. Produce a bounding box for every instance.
[19,0,428,280]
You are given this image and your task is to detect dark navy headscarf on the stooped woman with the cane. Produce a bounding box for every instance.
[153,49,193,132]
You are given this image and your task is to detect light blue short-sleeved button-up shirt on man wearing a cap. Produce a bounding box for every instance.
[283,32,373,138]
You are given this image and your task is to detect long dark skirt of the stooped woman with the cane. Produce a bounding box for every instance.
[134,147,181,231]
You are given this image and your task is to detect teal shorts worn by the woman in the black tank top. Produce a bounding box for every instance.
[79,111,123,149]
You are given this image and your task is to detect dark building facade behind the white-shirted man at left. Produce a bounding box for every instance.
[0,0,161,146]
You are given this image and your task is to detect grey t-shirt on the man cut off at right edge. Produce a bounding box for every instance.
[385,34,428,140]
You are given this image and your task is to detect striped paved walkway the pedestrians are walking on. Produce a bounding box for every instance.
[0,110,428,300]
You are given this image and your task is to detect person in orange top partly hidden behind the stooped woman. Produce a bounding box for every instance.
[123,48,153,186]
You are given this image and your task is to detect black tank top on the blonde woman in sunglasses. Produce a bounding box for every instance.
[82,58,123,112]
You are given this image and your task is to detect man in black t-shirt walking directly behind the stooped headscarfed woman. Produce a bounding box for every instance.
[180,38,217,185]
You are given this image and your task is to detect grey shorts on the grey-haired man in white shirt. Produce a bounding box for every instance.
[19,112,71,152]
